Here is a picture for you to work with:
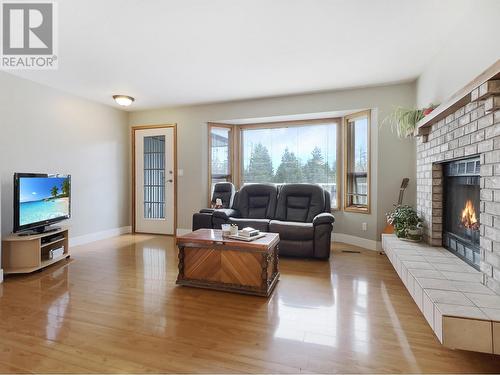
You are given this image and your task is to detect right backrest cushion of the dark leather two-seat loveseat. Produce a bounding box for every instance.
[275,184,326,223]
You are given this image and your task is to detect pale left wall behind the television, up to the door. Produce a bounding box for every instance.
[0,73,130,250]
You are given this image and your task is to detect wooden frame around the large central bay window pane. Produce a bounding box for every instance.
[235,117,343,212]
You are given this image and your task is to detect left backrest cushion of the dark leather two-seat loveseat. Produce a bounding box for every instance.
[234,184,278,219]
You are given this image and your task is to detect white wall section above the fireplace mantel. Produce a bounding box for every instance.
[417,0,500,107]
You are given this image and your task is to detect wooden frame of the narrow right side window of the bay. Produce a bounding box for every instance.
[343,109,371,214]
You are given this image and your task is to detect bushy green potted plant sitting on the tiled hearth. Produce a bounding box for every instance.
[386,205,423,242]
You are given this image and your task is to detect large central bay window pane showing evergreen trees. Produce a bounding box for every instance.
[240,119,341,208]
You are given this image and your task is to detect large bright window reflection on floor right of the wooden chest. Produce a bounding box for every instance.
[274,261,371,354]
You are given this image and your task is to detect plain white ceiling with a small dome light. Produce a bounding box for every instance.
[8,0,474,110]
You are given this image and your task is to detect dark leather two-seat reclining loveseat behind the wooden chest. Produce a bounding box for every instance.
[205,184,335,259]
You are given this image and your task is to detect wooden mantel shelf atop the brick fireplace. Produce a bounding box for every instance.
[415,60,500,142]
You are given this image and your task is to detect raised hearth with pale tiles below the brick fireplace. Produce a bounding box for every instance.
[382,234,500,354]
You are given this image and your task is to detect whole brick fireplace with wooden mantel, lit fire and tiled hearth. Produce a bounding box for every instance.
[382,60,500,355]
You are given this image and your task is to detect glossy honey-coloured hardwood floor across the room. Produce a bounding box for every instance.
[0,235,500,373]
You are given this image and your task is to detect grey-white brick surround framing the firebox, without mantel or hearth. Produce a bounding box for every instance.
[417,93,500,294]
